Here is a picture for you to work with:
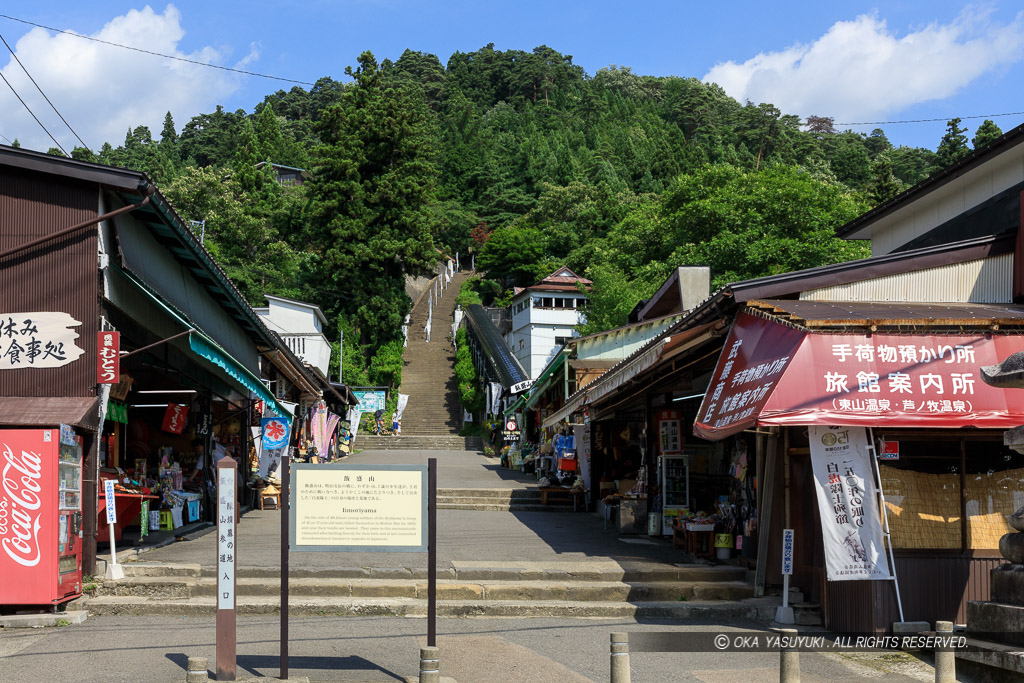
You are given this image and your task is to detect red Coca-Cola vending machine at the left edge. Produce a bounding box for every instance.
[0,425,82,605]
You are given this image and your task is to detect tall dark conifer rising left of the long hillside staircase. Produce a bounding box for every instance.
[306,52,437,349]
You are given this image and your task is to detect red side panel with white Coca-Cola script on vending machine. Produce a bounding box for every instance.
[0,429,59,605]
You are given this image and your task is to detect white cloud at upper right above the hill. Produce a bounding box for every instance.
[703,7,1024,122]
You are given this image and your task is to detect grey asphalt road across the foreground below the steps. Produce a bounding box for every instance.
[0,616,934,683]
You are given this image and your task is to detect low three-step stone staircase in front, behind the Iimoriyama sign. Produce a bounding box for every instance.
[73,562,779,622]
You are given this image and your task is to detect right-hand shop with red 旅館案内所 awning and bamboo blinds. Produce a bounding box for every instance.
[695,301,1024,632]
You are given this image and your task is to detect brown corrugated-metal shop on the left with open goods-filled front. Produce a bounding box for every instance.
[0,147,319,602]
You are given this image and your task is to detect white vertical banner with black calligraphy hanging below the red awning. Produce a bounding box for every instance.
[810,426,892,581]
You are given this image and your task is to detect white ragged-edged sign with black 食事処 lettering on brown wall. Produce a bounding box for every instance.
[0,311,85,370]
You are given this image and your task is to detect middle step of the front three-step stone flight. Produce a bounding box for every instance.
[94,577,754,602]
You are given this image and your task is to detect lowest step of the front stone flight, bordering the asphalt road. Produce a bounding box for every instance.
[69,595,779,623]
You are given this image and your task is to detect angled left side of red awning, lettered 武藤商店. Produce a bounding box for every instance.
[693,313,805,441]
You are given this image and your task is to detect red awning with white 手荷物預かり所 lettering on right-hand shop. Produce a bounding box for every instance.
[693,309,1024,440]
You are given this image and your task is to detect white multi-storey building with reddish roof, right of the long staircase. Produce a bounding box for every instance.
[505,268,592,380]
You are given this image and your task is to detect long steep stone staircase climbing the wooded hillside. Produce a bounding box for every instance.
[395,272,469,438]
